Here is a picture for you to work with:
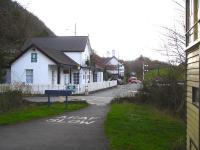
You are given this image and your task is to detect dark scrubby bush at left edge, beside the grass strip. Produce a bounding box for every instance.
[0,90,23,112]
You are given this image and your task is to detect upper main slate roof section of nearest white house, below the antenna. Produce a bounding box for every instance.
[22,36,88,52]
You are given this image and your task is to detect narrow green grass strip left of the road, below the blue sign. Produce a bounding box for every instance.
[0,102,88,125]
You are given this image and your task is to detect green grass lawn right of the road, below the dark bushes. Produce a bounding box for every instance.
[105,103,185,150]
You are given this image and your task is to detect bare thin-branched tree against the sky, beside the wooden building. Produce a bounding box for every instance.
[156,0,186,66]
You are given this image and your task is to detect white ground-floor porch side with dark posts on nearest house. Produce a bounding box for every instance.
[48,65,103,85]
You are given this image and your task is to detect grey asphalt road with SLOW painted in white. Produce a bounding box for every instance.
[0,86,141,150]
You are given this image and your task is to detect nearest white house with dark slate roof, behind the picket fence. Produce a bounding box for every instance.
[10,36,103,85]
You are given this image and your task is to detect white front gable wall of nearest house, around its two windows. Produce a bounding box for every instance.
[11,49,55,84]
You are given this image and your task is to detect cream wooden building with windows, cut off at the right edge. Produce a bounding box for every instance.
[186,0,200,150]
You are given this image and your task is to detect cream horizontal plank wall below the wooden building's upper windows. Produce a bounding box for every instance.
[187,49,199,150]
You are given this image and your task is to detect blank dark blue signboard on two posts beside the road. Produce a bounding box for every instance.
[45,90,72,105]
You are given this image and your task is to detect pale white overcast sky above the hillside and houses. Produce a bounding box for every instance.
[14,0,183,61]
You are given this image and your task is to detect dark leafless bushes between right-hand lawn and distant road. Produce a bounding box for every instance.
[112,81,186,119]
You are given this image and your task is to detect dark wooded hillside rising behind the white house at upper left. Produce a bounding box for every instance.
[0,0,55,56]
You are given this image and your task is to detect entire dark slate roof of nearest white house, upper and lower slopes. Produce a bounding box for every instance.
[10,36,89,66]
